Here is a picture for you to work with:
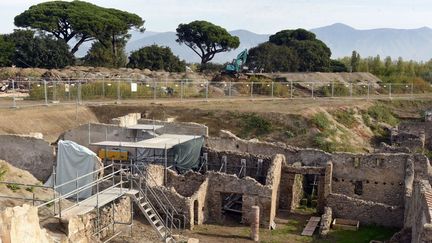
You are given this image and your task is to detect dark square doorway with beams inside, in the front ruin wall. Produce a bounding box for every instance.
[221,193,243,224]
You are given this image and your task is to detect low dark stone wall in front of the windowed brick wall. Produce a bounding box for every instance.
[327,193,404,228]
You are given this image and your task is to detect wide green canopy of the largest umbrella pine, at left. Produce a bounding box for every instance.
[14,1,144,54]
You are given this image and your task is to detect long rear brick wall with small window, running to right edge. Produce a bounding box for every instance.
[206,128,432,231]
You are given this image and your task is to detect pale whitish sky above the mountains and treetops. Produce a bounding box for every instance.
[0,0,432,34]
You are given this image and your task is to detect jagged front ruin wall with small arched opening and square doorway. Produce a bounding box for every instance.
[148,155,284,228]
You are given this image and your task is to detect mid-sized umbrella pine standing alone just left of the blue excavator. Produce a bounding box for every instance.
[177,21,240,64]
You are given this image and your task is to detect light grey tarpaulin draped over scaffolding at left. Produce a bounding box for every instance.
[45,140,99,198]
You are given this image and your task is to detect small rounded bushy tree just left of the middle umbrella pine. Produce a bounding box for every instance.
[128,45,186,72]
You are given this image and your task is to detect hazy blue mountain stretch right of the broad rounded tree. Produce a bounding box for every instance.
[311,24,432,61]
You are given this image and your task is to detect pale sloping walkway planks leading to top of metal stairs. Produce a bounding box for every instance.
[56,187,136,219]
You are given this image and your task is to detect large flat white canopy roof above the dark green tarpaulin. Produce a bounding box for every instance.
[91,134,199,149]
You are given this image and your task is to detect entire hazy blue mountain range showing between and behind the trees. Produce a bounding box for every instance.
[77,23,432,63]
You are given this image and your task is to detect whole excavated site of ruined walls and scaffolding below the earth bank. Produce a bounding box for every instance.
[0,102,432,243]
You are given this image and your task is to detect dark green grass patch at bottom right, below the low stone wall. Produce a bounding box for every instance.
[313,225,398,243]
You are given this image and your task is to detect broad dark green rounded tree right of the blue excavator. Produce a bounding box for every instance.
[248,29,331,72]
